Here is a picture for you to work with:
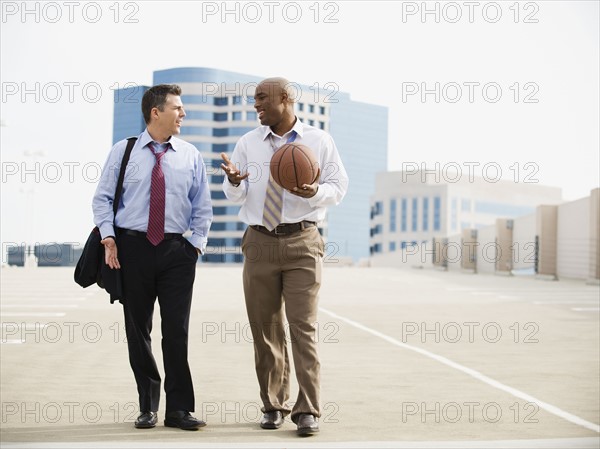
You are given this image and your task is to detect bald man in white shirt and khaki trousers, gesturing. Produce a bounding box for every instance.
[221,78,348,436]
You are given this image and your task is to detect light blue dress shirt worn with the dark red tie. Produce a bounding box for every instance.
[92,130,213,252]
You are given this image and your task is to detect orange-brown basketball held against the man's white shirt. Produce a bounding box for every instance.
[269,143,319,190]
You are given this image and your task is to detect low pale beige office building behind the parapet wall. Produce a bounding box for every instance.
[370,168,562,260]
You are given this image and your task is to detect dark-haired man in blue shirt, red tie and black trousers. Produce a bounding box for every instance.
[93,84,212,430]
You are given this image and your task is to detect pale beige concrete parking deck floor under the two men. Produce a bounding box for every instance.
[0,266,600,448]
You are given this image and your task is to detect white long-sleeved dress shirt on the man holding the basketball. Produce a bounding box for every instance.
[223,119,348,225]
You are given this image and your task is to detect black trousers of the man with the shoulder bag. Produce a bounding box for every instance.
[117,232,198,412]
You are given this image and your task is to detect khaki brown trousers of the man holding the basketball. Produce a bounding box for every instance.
[242,226,324,422]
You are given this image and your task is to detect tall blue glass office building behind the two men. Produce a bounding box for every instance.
[113,67,388,263]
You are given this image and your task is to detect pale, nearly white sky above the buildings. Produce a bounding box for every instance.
[0,1,600,248]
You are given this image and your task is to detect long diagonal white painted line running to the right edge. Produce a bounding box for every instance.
[319,307,600,433]
